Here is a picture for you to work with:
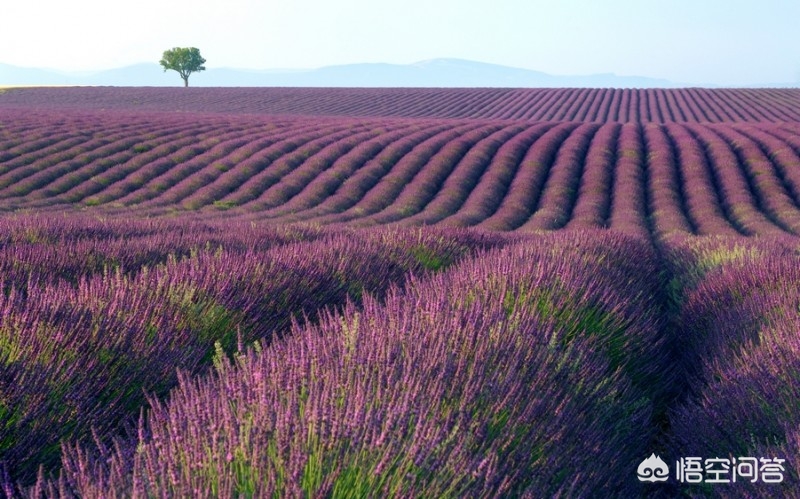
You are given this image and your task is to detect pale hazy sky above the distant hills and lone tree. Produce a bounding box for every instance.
[0,0,800,85]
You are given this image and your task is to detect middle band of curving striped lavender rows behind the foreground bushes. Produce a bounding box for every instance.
[0,109,800,238]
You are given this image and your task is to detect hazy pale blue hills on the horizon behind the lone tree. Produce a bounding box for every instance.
[0,59,681,88]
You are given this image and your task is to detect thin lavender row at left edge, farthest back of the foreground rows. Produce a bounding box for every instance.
[0,213,321,294]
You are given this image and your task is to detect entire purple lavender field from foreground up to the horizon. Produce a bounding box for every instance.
[0,88,800,497]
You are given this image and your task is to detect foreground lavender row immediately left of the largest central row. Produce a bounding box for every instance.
[0,223,502,481]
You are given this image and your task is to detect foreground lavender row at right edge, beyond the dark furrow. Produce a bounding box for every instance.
[668,237,800,497]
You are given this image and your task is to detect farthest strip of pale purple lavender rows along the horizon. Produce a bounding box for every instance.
[0,87,800,123]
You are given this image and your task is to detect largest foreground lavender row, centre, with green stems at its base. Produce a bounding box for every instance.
[21,229,669,497]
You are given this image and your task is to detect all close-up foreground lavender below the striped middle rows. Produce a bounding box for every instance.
[0,222,800,497]
